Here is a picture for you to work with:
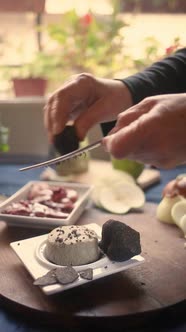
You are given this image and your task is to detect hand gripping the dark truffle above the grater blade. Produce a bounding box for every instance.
[44,74,132,142]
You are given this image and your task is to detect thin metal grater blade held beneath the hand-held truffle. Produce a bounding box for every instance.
[19,139,102,172]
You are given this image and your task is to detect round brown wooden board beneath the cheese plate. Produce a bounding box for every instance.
[0,203,186,328]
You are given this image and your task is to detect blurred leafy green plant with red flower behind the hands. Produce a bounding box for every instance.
[47,6,126,80]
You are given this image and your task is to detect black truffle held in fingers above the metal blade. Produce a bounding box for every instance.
[54,125,79,155]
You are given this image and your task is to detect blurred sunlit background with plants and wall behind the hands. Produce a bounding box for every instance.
[0,0,186,162]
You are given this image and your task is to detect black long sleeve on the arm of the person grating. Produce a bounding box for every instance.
[101,48,186,135]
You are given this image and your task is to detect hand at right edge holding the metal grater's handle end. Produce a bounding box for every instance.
[103,93,186,168]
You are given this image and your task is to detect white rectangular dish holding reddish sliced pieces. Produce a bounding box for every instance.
[0,181,93,229]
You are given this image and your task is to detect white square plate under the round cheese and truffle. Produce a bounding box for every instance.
[10,224,144,295]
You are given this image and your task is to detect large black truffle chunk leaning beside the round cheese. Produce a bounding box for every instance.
[99,219,141,262]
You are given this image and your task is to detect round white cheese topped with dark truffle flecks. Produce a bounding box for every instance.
[45,225,100,266]
